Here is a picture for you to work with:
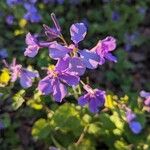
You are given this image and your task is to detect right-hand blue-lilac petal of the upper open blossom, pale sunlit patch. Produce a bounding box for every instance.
[79,50,100,69]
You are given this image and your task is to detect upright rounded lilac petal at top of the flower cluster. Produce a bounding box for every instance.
[70,23,87,44]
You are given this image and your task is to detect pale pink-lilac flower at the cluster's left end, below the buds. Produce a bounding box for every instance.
[24,33,40,57]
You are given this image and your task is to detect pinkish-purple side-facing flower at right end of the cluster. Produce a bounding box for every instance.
[91,36,117,65]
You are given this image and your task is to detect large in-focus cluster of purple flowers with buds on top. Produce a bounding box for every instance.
[20,13,117,113]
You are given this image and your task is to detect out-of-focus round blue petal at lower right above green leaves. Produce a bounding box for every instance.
[129,121,142,134]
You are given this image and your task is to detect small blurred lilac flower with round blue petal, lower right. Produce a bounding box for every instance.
[126,109,142,134]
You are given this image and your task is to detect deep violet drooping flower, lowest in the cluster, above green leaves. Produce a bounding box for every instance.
[78,85,105,113]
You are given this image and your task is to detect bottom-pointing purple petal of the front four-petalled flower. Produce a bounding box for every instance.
[53,80,67,102]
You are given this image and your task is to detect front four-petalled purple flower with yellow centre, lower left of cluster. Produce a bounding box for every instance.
[38,57,80,102]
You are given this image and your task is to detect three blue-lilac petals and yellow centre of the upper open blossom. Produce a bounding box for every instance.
[49,23,100,69]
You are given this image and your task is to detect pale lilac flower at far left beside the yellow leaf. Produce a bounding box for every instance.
[5,59,39,88]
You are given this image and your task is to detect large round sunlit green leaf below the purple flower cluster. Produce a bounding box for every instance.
[52,103,83,136]
